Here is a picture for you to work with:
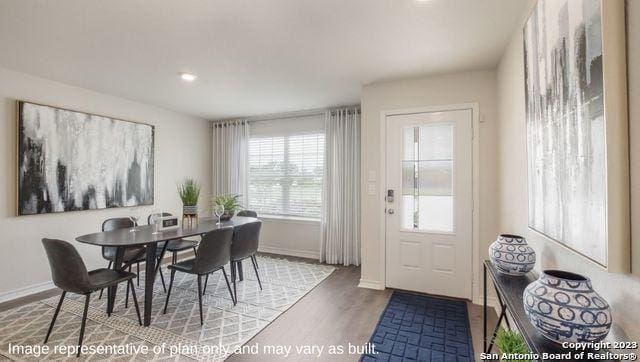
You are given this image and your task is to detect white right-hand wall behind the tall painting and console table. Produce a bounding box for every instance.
[498,1,640,341]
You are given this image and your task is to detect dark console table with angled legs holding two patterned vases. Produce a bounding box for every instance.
[482,260,613,361]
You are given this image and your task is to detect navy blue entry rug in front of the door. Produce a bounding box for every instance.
[360,292,474,362]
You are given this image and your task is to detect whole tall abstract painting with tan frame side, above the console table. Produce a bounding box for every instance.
[523,0,630,271]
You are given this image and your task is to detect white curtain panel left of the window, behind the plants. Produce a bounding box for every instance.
[213,120,249,206]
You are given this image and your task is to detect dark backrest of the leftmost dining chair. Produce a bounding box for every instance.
[42,239,91,294]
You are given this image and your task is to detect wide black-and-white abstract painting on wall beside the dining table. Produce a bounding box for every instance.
[18,101,154,215]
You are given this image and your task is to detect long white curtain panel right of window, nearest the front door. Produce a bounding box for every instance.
[320,107,360,265]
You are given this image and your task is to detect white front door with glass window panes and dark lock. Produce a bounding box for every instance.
[386,109,473,299]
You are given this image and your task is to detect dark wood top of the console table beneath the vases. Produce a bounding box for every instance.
[484,260,614,361]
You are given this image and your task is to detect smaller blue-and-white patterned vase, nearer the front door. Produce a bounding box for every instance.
[489,234,536,275]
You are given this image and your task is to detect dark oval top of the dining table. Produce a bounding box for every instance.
[76,216,258,246]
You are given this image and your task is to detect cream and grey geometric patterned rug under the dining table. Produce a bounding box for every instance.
[0,255,335,361]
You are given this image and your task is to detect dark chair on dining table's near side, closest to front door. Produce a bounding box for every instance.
[231,220,262,299]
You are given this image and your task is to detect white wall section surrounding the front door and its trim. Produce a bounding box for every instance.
[361,71,498,300]
